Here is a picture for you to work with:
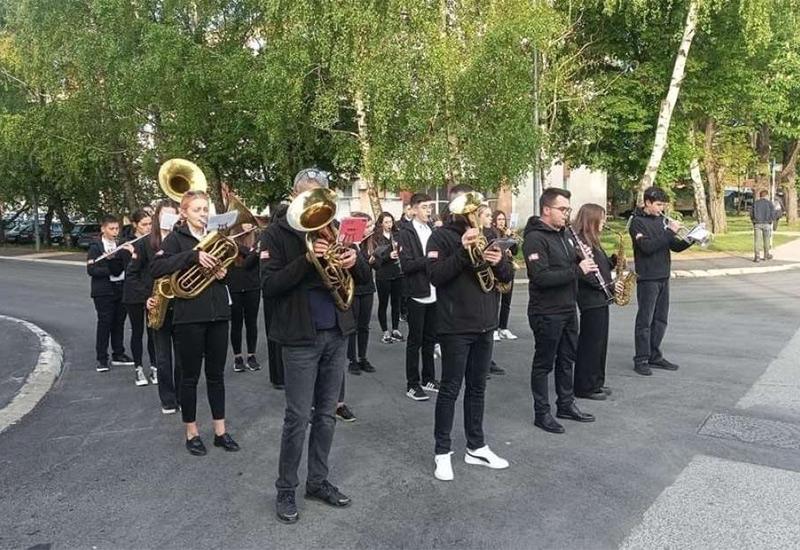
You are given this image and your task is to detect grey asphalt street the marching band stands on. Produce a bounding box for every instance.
[0,260,800,549]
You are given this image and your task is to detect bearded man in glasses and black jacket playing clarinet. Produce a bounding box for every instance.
[522,187,597,433]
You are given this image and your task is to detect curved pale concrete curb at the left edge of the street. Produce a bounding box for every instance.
[0,315,64,433]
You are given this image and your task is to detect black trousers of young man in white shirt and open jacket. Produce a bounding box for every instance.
[406,298,436,389]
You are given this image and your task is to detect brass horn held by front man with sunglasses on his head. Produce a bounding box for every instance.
[286,187,355,311]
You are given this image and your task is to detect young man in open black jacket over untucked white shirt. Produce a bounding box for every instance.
[397,193,439,401]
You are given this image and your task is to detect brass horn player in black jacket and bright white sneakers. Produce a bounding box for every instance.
[426,185,513,481]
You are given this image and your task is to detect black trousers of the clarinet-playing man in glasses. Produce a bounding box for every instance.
[528,311,578,416]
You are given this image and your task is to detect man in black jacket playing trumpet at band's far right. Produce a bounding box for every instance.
[628,187,692,376]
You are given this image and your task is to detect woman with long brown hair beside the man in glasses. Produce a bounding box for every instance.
[574,203,623,401]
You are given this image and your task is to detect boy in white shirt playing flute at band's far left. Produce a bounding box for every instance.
[86,215,134,372]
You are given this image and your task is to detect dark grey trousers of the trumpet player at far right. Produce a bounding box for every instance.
[633,279,669,365]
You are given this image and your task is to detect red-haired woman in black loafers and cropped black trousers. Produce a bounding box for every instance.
[151,191,239,456]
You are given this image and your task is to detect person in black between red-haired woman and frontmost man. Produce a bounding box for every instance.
[228,224,261,372]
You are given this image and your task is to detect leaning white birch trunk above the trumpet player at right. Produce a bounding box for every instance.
[638,0,698,204]
